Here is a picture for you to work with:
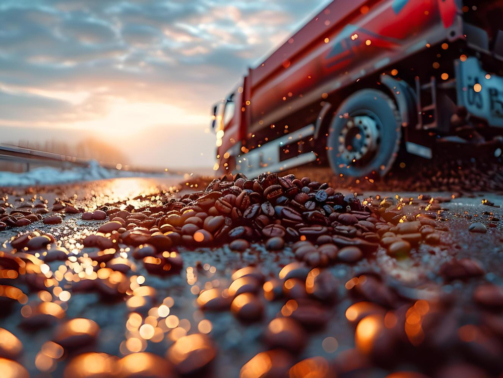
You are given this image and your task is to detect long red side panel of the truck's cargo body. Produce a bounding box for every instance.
[250,0,447,132]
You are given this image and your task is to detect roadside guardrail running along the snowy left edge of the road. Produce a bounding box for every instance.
[0,144,171,175]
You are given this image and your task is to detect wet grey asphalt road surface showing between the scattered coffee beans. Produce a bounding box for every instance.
[0,179,503,377]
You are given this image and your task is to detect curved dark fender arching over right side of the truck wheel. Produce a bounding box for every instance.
[381,75,418,129]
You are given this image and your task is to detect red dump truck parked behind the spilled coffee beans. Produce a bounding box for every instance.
[212,0,503,177]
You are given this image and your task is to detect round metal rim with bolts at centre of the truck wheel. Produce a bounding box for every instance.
[338,114,381,166]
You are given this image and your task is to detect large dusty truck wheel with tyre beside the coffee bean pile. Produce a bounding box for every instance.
[327,89,401,177]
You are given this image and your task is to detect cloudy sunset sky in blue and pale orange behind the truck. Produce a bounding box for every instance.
[0,0,330,168]
